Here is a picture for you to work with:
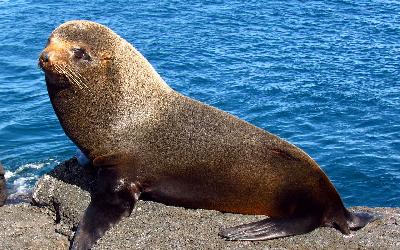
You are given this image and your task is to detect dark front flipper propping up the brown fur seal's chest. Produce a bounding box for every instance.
[70,167,140,250]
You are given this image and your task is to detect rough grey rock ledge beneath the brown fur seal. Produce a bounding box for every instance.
[0,159,400,249]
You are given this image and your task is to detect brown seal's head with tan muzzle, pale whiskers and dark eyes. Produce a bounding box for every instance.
[39,21,121,97]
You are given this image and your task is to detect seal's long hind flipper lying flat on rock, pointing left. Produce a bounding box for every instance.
[219,216,319,240]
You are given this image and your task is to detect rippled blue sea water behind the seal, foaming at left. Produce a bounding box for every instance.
[0,0,400,207]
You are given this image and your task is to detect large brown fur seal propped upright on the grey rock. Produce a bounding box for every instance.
[39,21,373,249]
